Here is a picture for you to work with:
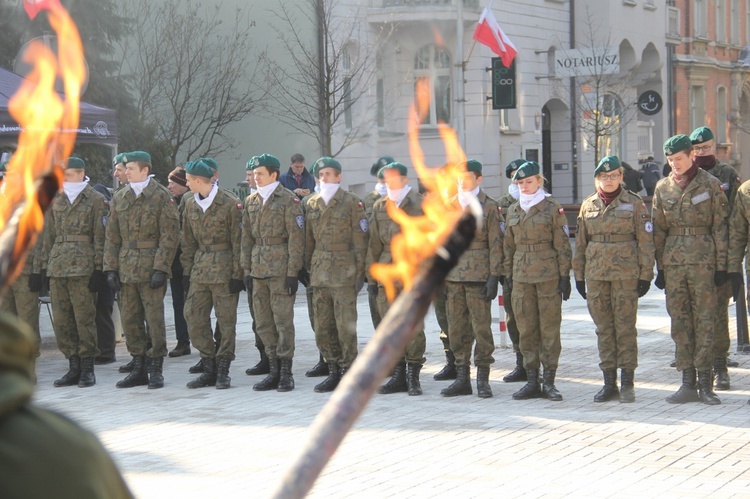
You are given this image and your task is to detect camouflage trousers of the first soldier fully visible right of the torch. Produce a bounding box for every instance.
[512,279,562,369]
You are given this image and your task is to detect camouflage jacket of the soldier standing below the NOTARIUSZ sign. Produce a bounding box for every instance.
[573,189,654,281]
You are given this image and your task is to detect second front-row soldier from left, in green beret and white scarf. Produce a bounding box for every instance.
[104,151,180,389]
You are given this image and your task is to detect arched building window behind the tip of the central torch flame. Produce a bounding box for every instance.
[414,45,451,125]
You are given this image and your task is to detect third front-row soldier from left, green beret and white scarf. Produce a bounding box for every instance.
[180,158,243,389]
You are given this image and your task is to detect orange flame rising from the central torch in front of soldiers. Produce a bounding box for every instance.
[370,80,466,301]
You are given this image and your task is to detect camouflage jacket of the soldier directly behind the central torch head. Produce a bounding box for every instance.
[445,189,505,282]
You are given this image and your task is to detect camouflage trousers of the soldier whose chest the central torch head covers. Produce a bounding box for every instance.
[445,282,495,366]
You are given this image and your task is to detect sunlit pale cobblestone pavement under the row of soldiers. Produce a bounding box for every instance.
[36,289,750,498]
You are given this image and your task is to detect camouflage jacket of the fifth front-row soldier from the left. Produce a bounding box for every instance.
[305,188,369,287]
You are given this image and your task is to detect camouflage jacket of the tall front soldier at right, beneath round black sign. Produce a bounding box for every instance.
[651,169,728,270]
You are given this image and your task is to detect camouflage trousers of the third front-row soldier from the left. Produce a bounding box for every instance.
[184,282,240,360]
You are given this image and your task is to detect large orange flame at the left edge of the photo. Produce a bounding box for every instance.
[0,4,86,282]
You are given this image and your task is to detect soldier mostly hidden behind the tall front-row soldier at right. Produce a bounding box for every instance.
[690,126,742,390]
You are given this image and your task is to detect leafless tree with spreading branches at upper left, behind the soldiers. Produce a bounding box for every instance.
[113,0,263,168]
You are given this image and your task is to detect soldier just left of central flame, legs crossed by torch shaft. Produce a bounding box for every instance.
[367,162,426,395]
